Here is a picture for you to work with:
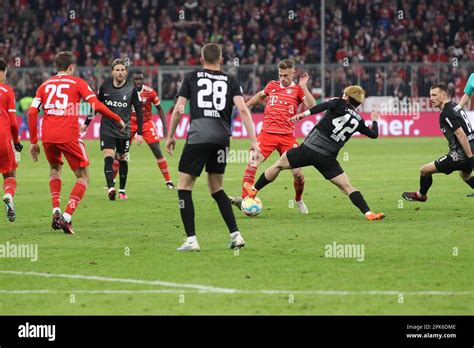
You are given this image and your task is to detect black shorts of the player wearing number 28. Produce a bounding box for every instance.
[178,143,228,176]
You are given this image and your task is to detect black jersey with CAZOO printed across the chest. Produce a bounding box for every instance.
[97,79,143,139]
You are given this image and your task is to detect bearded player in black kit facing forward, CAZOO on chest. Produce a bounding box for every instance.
[81,59,143,201]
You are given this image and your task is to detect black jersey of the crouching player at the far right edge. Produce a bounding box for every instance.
[439,102,474,159]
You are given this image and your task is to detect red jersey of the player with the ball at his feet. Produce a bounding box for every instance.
[262,81,305,134]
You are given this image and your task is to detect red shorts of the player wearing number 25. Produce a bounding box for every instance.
[43,139,89,170]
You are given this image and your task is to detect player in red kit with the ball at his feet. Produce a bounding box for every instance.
[229,59,316,214]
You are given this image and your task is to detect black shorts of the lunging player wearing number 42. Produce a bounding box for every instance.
[286,144,344,180]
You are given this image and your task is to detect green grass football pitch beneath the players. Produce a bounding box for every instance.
[0,138,474,315]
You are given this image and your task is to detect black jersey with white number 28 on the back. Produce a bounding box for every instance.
[178,68,242,146]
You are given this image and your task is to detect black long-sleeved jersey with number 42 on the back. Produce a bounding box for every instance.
[304,98,379,156]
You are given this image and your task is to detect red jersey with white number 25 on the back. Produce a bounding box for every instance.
[31,74,96,144]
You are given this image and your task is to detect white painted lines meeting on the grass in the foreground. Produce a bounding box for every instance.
[0,270,474,296]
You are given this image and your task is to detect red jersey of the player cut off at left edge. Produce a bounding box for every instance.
[0,83,18,144]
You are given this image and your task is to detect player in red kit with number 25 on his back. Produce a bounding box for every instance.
[28,51,125,234]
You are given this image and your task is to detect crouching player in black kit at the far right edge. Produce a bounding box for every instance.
[402,84,474,202]
